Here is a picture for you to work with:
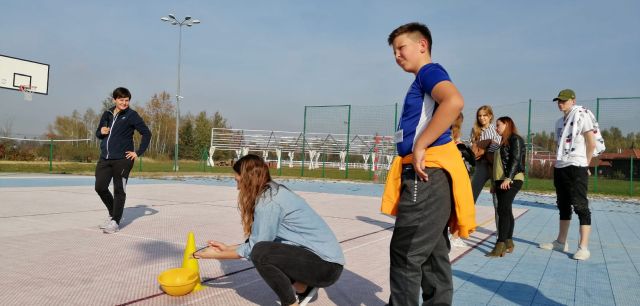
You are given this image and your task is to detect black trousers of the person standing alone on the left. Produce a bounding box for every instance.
[95,158,133,224]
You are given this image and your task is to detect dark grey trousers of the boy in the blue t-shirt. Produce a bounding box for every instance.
[389,165,453,306]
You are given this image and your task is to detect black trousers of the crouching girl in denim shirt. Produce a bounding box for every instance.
[251,241,343,305]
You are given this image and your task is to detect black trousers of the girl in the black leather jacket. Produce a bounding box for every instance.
[493,180,522,242]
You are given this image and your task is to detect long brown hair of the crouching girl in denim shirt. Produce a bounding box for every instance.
[233,154,271,237]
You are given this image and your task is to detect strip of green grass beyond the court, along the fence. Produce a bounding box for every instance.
[0,159,640,198]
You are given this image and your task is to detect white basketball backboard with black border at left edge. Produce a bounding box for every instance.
[0,54,49,95]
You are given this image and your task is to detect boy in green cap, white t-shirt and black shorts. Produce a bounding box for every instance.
[540,89,604,260]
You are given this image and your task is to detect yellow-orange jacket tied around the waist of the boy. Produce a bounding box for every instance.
[380,141,476,238]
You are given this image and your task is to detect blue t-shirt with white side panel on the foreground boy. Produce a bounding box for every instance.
[396,63,451,156]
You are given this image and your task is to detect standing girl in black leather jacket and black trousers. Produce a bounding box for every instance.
[487,117,526,257]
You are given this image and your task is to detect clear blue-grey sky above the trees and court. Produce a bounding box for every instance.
[0,0,640,137]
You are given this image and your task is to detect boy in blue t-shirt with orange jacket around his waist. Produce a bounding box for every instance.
[387,23,475,305]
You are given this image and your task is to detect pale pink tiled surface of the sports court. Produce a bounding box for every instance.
[0,182,526,305]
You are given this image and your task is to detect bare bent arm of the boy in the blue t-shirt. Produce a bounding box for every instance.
[413,81,464,180]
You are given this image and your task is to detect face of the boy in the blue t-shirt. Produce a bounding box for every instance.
[392,33,430,74]
